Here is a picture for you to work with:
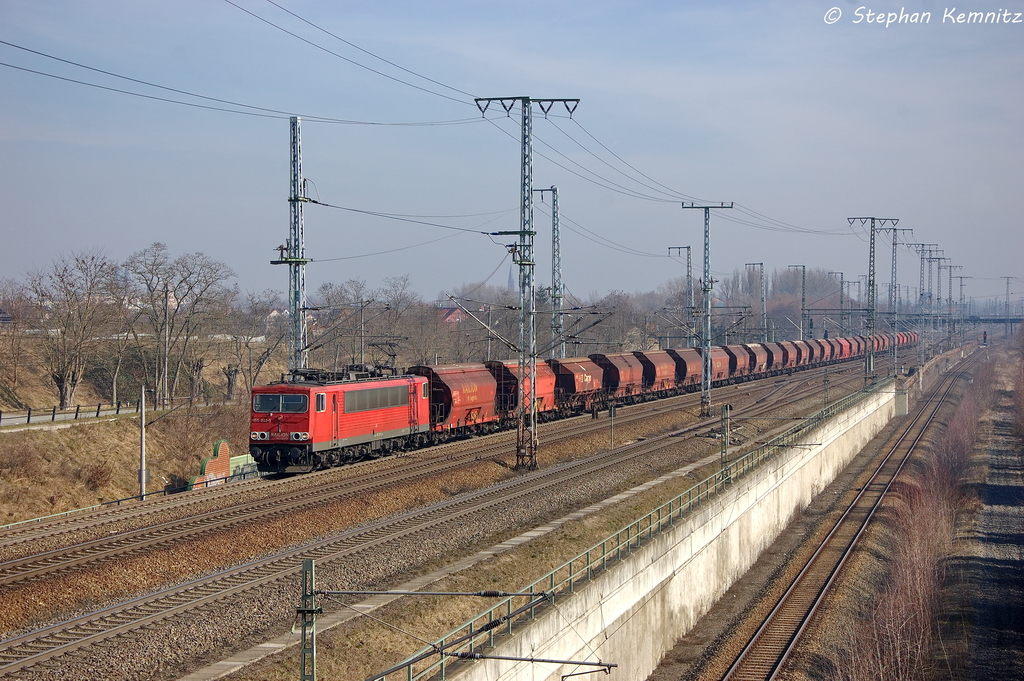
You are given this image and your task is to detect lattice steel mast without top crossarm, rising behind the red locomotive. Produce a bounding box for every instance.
[270,116,309,372]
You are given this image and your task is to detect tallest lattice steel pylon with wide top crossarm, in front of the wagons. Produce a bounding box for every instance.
[475,97,580,470]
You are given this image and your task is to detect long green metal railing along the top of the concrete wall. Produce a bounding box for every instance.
[376,379,893,681]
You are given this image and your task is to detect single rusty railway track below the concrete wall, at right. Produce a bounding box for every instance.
[722,355,980,681]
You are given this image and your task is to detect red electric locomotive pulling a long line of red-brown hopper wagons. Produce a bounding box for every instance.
[249,333,919,473]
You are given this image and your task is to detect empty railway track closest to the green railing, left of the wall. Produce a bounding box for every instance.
[0,360,868,675]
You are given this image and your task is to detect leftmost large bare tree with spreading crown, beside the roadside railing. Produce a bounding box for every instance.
[29,251,115,409]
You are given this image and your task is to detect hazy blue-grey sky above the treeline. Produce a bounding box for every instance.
[0,0,1024,299]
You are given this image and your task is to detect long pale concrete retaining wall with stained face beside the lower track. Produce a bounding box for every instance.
[447,390,895,681]
